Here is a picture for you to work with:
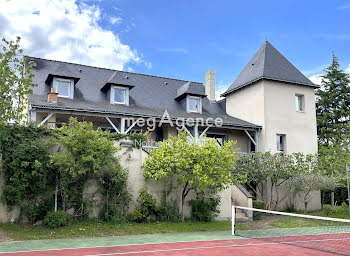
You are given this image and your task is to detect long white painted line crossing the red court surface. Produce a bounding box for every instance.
[84,238,350,256]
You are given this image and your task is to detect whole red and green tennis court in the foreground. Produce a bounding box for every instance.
[0,206,350,256]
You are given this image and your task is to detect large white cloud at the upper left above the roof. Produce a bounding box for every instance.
[0,0,142,70]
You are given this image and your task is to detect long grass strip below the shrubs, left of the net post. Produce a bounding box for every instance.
[0,220,250,240]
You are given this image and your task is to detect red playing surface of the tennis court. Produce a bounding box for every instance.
[0,233,350,256]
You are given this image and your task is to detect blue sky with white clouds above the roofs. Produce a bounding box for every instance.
[0,0,350,98]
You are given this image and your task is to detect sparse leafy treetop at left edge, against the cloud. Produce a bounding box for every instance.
[0,37,37,123]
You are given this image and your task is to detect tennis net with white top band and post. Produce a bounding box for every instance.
[232,206,350,255]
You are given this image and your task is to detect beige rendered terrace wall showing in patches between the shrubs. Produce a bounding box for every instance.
[0,141,231,222]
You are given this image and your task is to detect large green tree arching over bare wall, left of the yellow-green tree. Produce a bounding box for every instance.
[52,118,129,219]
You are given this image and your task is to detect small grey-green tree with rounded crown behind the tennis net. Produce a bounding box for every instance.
[290,173,337,214]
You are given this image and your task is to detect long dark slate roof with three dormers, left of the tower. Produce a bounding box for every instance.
[27,57,260,128]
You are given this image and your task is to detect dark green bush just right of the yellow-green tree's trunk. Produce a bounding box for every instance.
[188,194,220,222]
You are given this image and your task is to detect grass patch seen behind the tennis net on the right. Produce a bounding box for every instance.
[270,206,348,228]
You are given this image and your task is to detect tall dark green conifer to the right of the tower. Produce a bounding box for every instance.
[316,53,350,146]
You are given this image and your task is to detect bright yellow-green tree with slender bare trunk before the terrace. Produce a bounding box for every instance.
[143,132,245,220]
